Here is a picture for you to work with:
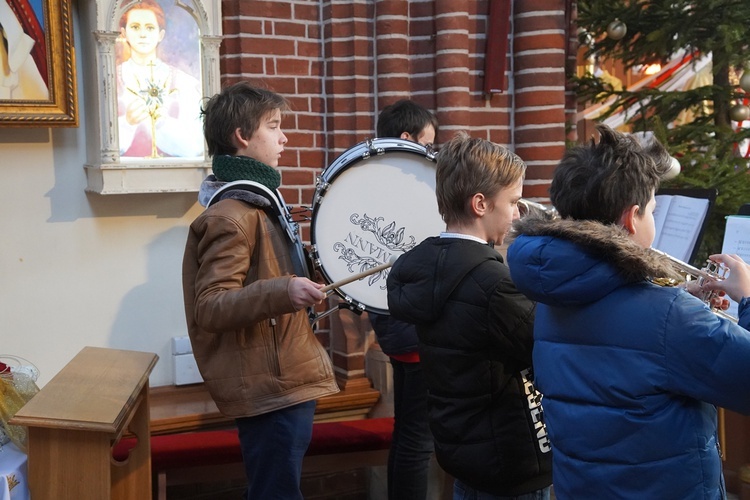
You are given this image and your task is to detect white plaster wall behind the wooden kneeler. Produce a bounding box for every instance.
[0,2,202,386]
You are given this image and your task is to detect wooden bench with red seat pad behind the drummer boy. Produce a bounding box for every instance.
[112,378,393,500]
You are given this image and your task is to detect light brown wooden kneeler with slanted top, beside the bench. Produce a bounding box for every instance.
[11,347,158,500]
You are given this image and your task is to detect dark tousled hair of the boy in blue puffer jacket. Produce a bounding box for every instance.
[549,124,671,224]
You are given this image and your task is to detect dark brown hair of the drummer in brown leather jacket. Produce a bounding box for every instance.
[201,82,289,156]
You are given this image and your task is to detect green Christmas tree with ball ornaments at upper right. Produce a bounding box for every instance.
[571,0,750,262]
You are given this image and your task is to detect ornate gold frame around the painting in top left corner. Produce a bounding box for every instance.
[0,0,78,127]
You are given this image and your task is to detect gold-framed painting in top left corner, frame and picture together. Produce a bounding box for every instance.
[0,0,78,127]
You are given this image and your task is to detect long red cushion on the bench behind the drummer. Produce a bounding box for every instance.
[112,417,393,470]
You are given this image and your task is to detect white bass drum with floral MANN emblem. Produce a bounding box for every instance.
[311,139,445,314]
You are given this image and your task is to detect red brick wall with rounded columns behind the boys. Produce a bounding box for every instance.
[221,0,575,382]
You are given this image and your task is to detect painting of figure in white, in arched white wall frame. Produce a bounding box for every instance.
[82,0,221,194]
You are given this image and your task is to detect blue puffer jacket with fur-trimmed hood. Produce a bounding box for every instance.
[508,219,750,500]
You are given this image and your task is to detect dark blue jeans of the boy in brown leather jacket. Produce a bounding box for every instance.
[235,401,315,500]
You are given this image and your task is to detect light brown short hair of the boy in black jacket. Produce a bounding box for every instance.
[435,132,526,228]
